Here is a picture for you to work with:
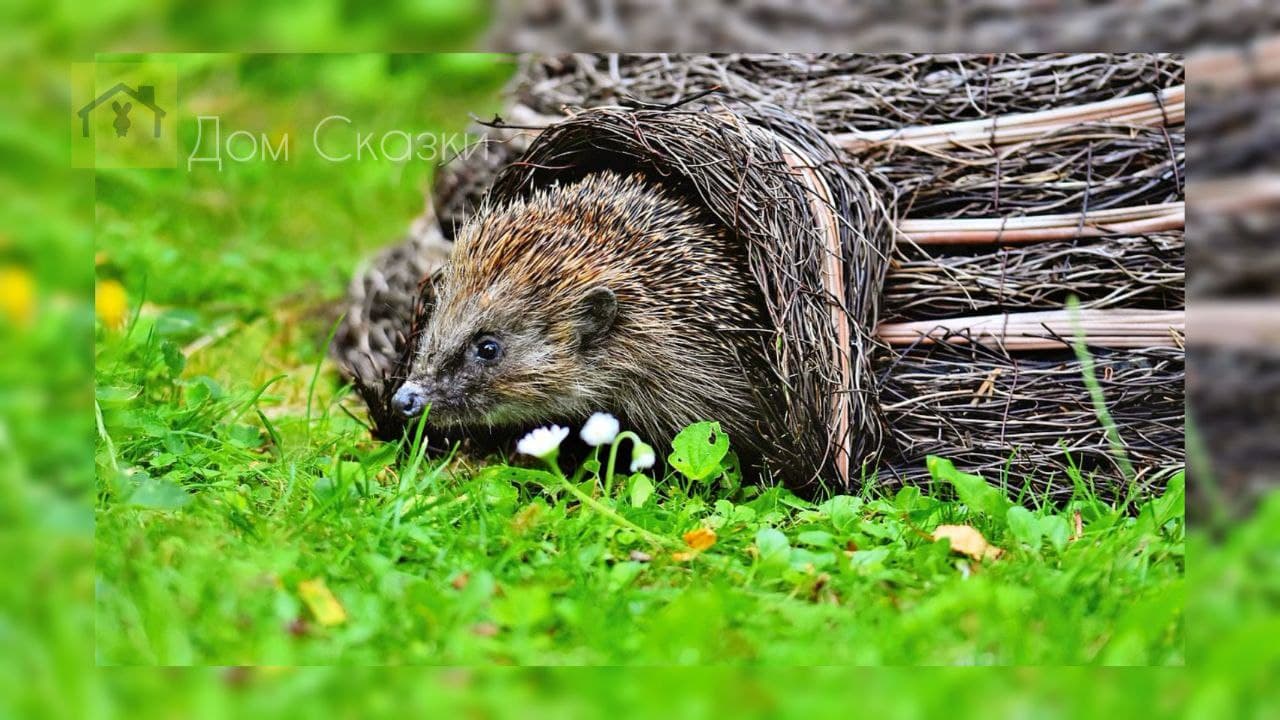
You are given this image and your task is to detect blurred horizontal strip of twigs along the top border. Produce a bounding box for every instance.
[488,0,1280,53]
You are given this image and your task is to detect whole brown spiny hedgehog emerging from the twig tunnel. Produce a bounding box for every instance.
[396,173,767,441]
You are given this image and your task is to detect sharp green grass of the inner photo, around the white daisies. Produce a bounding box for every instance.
[95,56,1185,665]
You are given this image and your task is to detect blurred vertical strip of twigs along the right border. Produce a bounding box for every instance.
[1188,36,1280,509]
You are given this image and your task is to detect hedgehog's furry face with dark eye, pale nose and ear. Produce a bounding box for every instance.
[393,279,617,427]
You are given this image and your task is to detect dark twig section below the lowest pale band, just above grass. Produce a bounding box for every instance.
[881,342,1184,497]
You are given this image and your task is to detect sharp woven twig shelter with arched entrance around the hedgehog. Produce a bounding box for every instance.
[335,55,1185,496]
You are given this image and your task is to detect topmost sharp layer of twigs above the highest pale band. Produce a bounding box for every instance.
[512,53,1184,130]
